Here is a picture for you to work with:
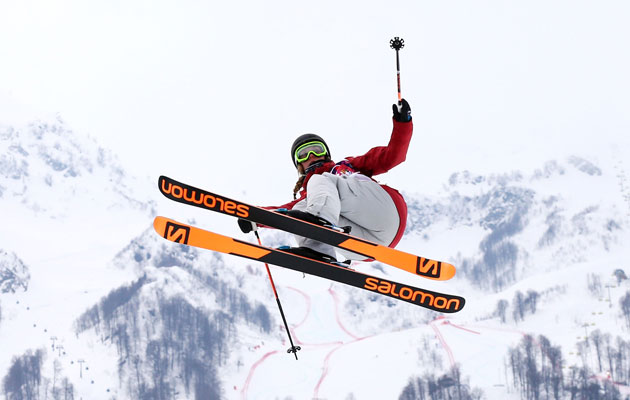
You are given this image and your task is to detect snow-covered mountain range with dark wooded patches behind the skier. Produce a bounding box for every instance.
[0,115,630,399]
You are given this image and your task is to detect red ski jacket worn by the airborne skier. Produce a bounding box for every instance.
[276,120,413,247]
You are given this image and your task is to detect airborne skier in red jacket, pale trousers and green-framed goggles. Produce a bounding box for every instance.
[239,99,413,263]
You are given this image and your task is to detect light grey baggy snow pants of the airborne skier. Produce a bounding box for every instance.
[293,172,400,260]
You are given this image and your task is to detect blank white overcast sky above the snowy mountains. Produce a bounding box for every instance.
[0,0,630,204]
